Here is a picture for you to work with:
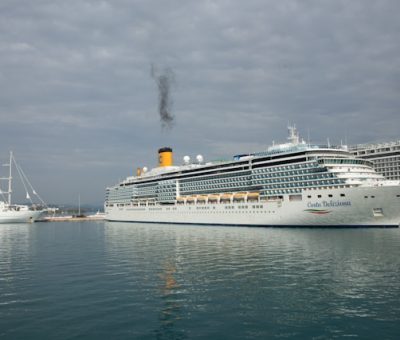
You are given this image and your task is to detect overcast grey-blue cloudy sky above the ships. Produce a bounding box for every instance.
[0,0,400,203]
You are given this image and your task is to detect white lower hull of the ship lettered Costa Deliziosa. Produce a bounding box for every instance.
[105,186,400,227]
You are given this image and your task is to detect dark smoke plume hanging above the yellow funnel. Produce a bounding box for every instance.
[150,64,175,129]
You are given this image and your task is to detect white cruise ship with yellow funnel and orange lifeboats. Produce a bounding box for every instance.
[104,127,400,227]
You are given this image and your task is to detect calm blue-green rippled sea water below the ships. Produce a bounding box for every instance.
[0,222,400,339]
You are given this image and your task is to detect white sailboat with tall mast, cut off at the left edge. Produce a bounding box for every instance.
[0,151,47,223]
